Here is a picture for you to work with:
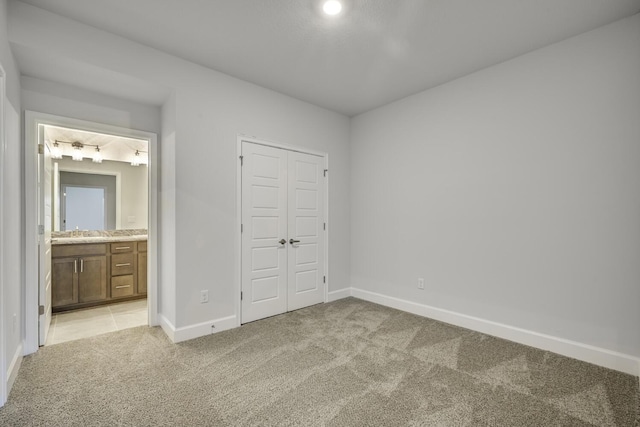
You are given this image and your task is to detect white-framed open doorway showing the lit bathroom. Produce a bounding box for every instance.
[25,112,157,354]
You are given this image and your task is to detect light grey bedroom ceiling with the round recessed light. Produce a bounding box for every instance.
[10,0,640,115]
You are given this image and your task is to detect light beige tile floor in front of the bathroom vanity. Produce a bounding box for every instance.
[45,299,147,345]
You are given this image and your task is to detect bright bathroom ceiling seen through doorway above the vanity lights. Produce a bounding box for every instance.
[44,126,149,164]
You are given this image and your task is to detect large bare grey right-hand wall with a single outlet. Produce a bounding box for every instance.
[351,15,640,357]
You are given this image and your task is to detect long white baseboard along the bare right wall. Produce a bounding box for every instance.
[350,288,640,376]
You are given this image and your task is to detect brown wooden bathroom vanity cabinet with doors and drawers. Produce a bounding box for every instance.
[51,241,147,311]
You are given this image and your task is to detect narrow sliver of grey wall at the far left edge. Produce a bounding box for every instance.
[0,0,24,405]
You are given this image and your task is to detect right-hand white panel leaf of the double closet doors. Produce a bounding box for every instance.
[287,151,324,311]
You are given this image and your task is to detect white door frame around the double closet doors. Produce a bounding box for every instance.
[235,134,331,326]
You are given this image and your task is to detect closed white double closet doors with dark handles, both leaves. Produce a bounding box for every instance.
[241,141,326,323]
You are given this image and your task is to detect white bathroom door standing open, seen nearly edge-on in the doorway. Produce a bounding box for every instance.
[38,139,53,345]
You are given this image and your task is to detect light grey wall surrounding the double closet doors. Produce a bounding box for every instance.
[10,2,350,338]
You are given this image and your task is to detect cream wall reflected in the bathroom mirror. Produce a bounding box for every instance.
[55,157,149,229]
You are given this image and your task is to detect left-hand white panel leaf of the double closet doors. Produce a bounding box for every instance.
[242,142,288,323]
